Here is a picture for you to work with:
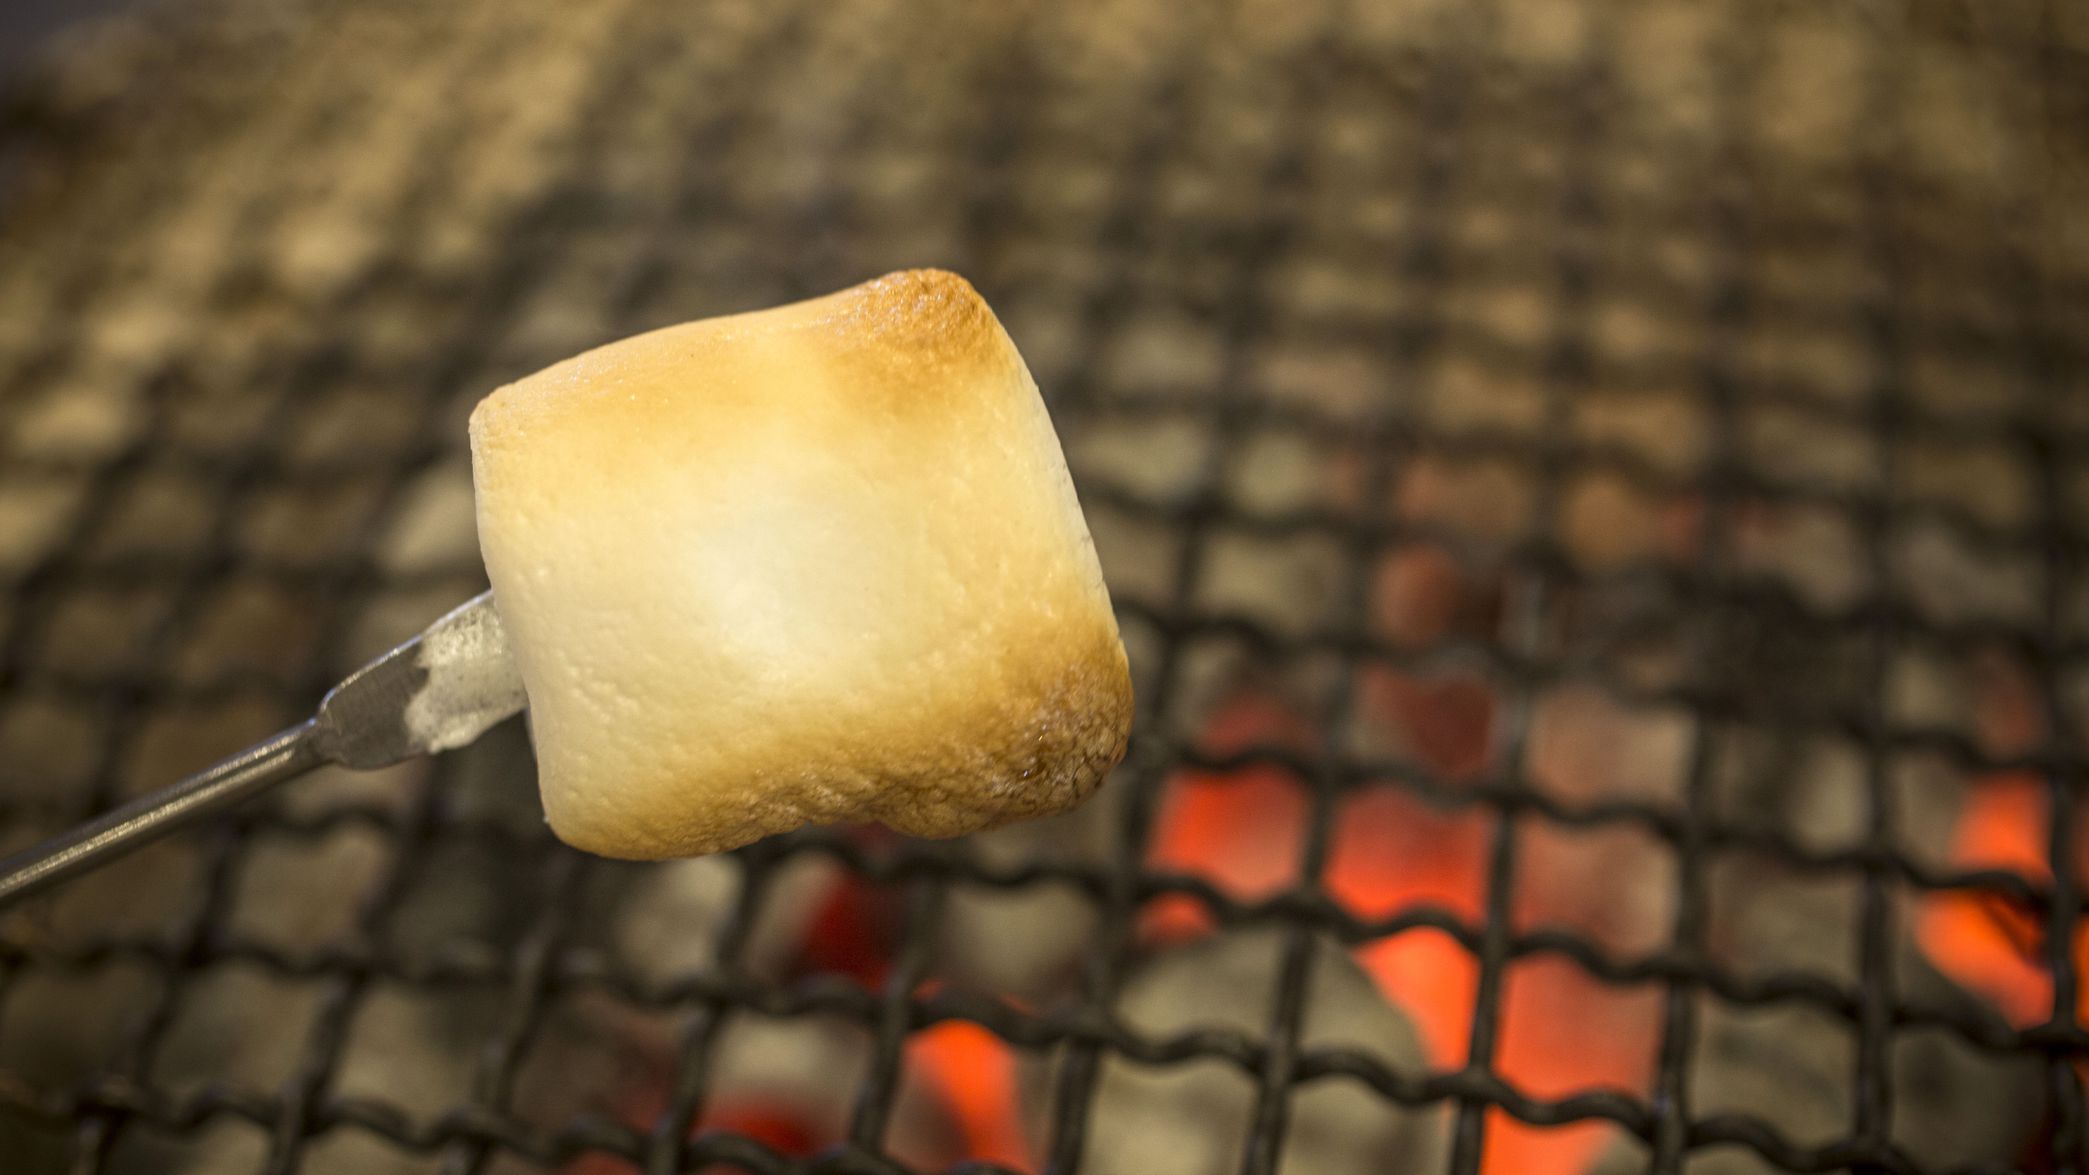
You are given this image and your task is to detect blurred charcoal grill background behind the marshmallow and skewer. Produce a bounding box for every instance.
[0,0,2089,1175]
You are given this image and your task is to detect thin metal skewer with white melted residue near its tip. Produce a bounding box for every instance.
[0,592,524,903]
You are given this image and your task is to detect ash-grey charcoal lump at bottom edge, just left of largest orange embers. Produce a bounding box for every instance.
[1084,928,1441,1175]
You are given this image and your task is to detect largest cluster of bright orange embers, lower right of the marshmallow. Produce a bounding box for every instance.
[1141,675,1659,1175]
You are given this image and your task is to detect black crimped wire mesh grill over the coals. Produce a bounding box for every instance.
[0,0,2089,1171]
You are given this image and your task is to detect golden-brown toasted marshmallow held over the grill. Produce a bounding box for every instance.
[472,270,1132,859]
